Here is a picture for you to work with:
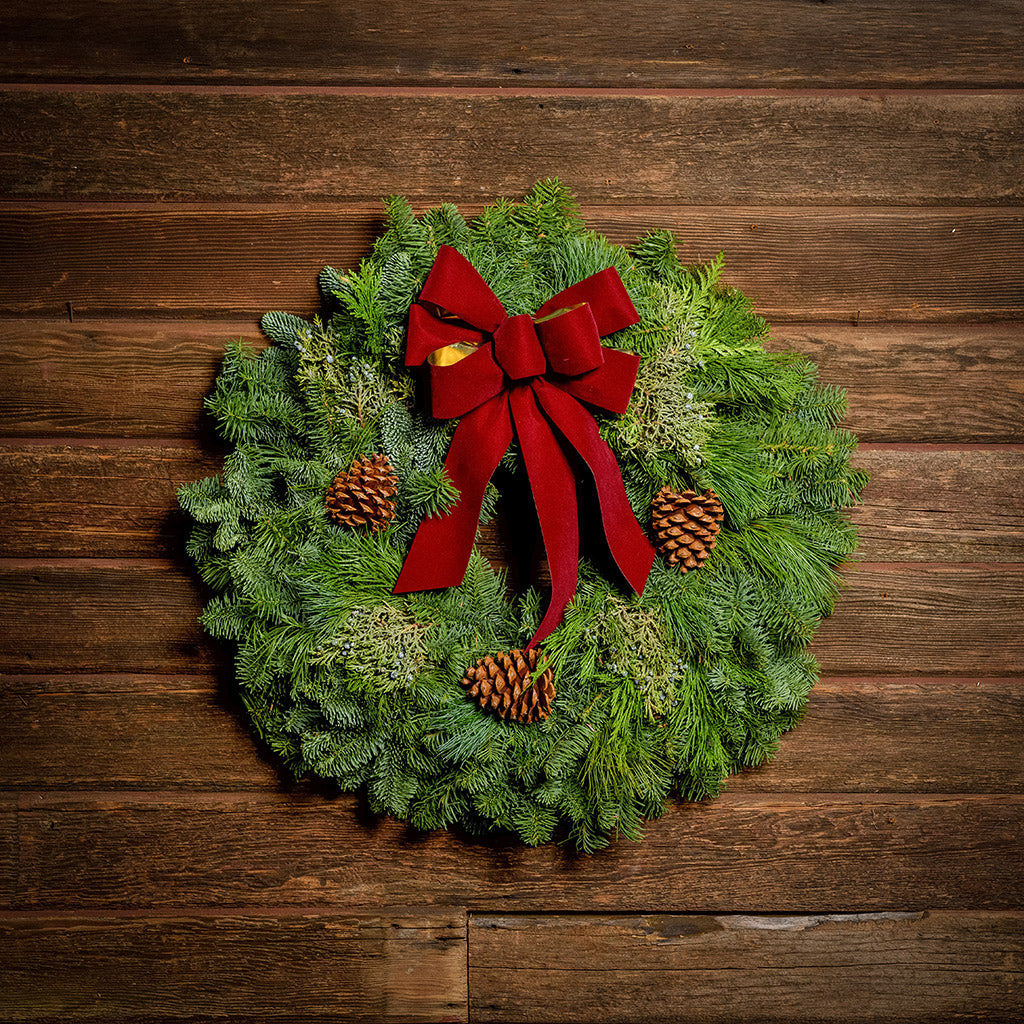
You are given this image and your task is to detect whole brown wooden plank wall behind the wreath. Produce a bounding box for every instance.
[0,0,1024,1024]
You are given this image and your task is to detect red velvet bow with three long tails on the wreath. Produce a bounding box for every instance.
[394,246,654,647]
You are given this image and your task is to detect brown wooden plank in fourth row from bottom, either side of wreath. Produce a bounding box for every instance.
[0,559,1024,676]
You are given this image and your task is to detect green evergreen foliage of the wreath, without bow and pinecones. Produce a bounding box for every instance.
[179,181,866,851]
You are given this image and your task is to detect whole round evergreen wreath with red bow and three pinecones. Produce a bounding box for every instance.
[180,181,866,851]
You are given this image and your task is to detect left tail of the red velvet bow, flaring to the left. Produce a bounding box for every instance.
[392,394,512,594]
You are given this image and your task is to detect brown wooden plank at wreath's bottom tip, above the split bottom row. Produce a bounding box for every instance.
[3,793,1024,913]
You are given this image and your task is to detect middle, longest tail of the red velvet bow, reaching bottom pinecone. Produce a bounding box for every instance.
[510,387,580,650]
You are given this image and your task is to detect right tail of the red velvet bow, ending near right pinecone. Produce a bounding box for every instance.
[534,381,655,594]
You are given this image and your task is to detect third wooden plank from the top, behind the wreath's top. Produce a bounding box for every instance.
[0,203,1024,319]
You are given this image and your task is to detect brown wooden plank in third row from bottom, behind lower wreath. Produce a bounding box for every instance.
[0,676,1024,794]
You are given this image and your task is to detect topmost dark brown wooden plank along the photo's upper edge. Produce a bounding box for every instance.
[0,0,1022,88]
